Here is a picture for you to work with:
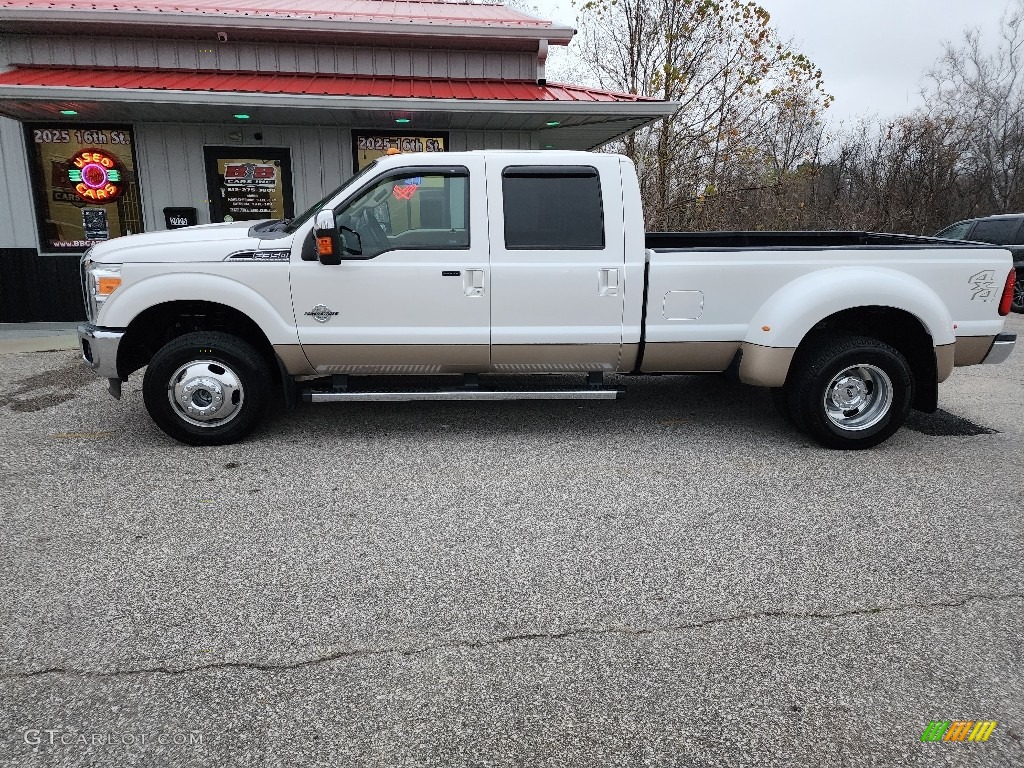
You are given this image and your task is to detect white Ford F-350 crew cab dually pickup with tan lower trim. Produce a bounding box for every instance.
[79,152,1016,449]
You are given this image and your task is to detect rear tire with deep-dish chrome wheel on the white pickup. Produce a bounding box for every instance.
[785,334,913,451]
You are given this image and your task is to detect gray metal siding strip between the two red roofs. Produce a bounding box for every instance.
[0,35,538,80]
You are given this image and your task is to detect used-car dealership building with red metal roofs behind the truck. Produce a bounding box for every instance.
[0,0,672,323]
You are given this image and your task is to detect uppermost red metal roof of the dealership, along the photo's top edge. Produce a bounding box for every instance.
[0,0,554,30]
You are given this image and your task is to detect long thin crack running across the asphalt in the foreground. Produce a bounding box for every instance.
[0,592,1024,680]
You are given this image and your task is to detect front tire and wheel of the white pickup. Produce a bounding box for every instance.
[142,331,270,445]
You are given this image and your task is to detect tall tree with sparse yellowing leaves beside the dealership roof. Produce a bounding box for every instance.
[575,0,830,229]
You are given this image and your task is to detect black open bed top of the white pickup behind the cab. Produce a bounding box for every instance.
[645,231,978,251]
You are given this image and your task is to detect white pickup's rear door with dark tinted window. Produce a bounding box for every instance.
[487,156,625,372]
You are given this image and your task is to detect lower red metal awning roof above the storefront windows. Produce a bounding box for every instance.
[0,66,658,101]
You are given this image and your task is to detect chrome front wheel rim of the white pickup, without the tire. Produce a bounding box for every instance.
[167,360,245,428]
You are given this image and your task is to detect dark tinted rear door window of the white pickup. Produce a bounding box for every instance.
[502,166,604,250]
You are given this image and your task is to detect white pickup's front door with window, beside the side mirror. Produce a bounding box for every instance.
[292,158,490,374]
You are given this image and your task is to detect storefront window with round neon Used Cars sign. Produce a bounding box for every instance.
[26,125,142,253]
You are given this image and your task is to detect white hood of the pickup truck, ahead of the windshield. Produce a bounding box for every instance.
[83,221,292,264]
